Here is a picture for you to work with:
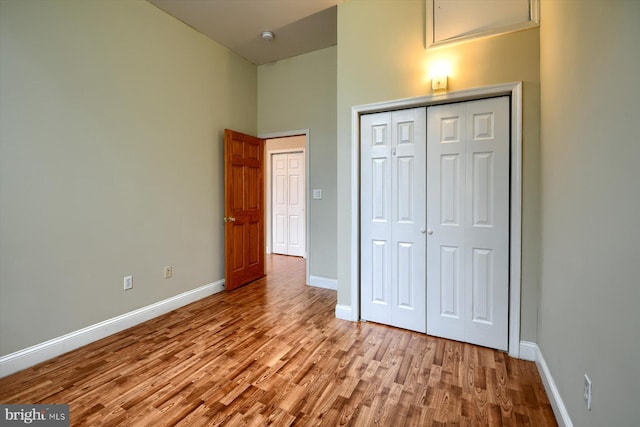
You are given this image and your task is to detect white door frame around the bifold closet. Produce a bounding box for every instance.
[348,82,522,357]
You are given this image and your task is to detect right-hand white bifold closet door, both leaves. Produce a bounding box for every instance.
[427,97,509,350]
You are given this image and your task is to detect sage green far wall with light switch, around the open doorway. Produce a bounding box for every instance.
[258,46,337,279]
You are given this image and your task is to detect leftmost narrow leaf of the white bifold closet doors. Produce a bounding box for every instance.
[360,113,392,324]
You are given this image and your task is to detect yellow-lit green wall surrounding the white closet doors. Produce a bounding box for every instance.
[337,0,540,341]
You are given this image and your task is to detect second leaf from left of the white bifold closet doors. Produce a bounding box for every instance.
[391,108,426,332]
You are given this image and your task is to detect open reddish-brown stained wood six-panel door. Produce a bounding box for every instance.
[224,129,265,291]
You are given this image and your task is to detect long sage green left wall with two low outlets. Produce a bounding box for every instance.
[0,0,257,355]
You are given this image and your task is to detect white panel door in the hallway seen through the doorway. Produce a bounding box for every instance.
[271,152,305,256]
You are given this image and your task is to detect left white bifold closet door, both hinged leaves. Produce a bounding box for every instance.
[360,108,426,332]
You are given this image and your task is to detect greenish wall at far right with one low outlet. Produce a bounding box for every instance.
[538,0,640,427]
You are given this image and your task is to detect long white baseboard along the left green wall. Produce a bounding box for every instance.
[0,280,224,378]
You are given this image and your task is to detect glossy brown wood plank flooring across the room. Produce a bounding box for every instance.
[0,256,557,426]
